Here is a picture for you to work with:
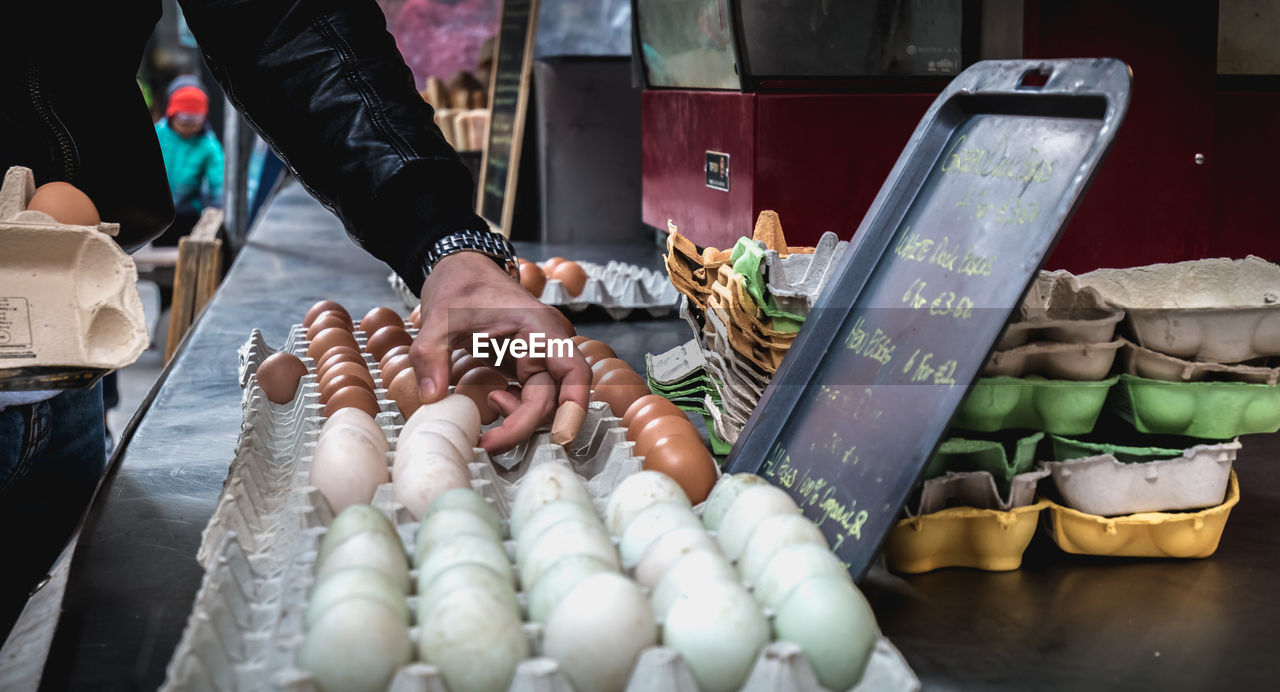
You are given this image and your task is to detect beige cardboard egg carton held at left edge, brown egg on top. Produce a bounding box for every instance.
[0,166,148,390]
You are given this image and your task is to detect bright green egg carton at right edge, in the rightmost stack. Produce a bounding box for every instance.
[1108,375,1280,440]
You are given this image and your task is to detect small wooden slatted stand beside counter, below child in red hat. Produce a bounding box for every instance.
[164,208,223,362]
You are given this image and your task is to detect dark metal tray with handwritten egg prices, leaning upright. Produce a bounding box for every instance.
[728,60,1130,579]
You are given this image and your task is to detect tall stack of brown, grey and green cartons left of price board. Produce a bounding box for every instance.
[649,211,847,454]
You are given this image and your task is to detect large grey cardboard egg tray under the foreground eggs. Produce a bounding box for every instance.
[164,326,919,692]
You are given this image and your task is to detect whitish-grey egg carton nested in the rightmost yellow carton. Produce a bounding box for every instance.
[1039,439,1240,517]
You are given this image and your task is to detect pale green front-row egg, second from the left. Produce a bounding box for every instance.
[417,588,529,692]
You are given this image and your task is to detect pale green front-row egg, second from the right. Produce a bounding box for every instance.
[662,581,772,692]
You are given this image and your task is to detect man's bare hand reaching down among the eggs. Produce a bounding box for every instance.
[410,252,591,453]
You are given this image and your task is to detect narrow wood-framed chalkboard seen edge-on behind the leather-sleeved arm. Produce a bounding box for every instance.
[476,0,538,237]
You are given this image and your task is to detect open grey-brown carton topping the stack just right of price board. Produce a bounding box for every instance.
[996,271,1124,350]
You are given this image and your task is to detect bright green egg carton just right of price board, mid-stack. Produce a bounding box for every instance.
[951,376,1116,435]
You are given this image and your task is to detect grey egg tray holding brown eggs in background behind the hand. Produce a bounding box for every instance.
[388,261,678,320]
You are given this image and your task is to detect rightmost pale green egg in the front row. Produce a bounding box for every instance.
[773,577,878,689]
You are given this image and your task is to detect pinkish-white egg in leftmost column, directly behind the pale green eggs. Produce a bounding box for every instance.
[310,427,390,513]
